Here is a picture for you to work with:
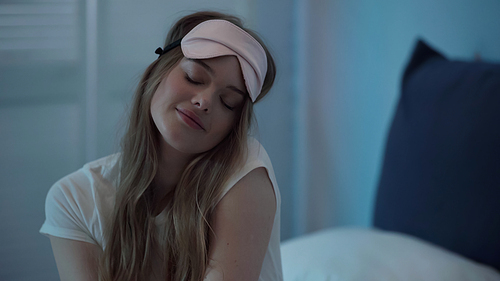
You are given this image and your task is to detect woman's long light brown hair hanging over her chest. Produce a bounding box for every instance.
[99,12,276,281]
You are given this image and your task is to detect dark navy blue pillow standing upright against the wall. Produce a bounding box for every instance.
[374,41,500,270]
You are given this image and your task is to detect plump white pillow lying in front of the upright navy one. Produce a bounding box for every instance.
[281,228,500,281]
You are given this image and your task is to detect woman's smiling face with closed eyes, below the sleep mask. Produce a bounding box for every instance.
[151,56,248,154]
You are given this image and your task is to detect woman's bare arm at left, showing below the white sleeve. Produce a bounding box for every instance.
[50,236,102,281]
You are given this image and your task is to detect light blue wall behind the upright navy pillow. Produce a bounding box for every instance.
[293,0,500,235]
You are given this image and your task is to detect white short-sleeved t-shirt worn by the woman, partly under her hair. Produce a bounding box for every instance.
[40,138,283,281]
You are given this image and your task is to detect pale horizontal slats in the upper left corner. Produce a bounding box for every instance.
[0,0,80,62]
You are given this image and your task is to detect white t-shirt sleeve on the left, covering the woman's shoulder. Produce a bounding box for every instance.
[40,170,98,245]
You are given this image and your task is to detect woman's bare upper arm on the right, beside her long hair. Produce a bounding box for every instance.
[205,167,276,281]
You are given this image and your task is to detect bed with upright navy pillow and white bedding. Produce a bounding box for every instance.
[282,40,500,281]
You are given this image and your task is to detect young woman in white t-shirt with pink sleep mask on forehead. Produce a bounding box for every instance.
[40,12,282,281]
